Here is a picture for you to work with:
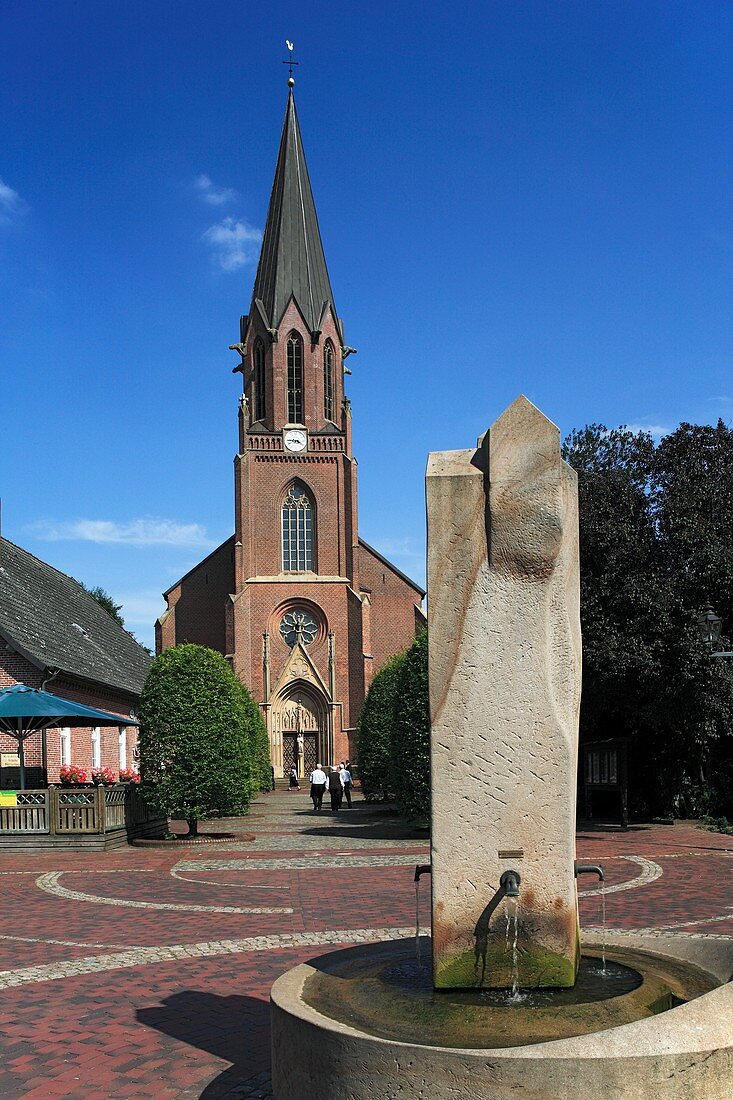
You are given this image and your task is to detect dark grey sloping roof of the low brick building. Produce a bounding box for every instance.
[0,538,151,695]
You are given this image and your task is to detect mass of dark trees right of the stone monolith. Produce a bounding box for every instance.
[564,421,733,816]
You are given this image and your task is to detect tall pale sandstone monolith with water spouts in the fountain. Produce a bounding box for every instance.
[427,397,581,989]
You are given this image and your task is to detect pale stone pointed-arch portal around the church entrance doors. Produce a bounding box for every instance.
[270,680,333,778]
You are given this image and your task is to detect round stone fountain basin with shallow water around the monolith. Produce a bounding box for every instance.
[271,934,733,1100]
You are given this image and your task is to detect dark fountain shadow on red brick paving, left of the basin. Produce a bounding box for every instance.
[135,990,271,1100]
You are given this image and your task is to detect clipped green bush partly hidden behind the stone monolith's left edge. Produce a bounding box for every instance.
[391,630,430,817]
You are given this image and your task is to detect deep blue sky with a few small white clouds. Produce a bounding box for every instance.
[0,0,733,645]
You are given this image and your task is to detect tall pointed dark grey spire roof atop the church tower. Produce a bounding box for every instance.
[250,90,339,332]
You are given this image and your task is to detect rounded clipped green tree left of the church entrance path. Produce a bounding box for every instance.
[140,645,252,836]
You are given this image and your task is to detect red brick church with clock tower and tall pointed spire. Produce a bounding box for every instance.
[156,90,425,776]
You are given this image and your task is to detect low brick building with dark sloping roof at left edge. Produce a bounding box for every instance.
[0,538,151,789]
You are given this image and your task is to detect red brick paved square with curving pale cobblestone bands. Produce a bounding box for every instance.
[0,791,733,1100]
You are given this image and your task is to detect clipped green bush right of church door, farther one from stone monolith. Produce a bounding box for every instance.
[357,653,405,802]
